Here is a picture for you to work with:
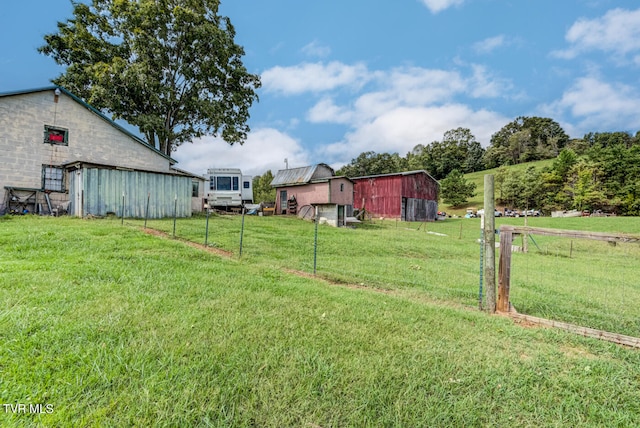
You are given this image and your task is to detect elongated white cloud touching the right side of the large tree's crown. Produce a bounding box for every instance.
[261,61,369,95]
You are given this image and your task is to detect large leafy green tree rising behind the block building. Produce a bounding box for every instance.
[39,0,260,155]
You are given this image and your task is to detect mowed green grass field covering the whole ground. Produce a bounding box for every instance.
[0,216,640,427]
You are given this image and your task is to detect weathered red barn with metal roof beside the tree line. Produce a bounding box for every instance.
[352,170,440,221]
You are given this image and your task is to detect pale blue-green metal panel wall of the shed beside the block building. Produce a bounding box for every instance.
[70,168,192,218]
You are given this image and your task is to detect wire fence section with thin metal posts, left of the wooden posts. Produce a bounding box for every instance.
[127,215,480,306]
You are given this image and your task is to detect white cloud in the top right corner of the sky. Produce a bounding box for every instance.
[553,9,640,60]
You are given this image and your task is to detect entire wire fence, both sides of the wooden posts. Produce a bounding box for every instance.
[122,215,640,336]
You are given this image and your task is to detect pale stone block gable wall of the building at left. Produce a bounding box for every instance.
[0,87,185,214]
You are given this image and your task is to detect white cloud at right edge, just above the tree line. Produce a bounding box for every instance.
[541,77,640,136]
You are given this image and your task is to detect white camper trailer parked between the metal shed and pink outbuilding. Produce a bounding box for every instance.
[205,168,253,208]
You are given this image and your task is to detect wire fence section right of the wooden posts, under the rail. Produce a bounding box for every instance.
[510,235,640,337]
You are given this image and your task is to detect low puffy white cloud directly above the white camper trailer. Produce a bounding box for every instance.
[173,128,309,175]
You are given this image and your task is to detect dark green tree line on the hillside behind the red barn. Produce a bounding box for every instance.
[337,117,640,215]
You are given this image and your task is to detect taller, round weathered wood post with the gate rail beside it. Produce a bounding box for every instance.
[484,174,496,313]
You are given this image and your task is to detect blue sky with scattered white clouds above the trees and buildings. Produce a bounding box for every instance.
[0,0,640,175]
